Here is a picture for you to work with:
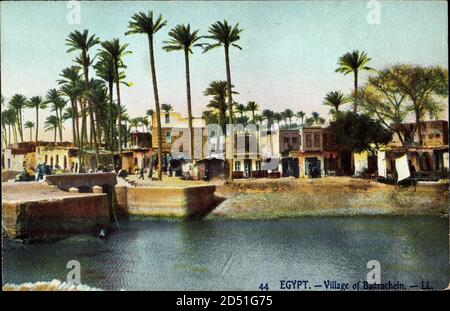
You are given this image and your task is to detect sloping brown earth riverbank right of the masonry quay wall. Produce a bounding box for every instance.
[207,177,448,219]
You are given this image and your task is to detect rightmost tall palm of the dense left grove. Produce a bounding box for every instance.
[100,39,131,159]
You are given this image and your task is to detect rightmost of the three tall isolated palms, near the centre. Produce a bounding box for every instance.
[204,20,242,180]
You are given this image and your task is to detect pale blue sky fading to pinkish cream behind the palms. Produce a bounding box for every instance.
[0,0,448,139]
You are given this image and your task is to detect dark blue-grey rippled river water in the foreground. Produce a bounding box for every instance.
[3,216,449,290]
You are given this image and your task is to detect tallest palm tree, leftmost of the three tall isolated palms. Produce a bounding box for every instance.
[125,11,167,180]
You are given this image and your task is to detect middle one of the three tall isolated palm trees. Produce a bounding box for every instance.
[163,24,203,160]
